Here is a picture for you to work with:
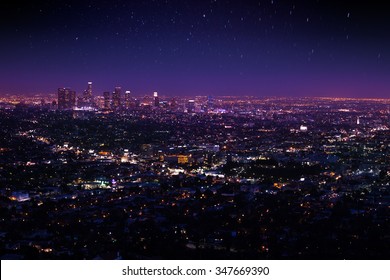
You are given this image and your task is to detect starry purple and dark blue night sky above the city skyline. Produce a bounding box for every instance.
[0,0,390,98]
